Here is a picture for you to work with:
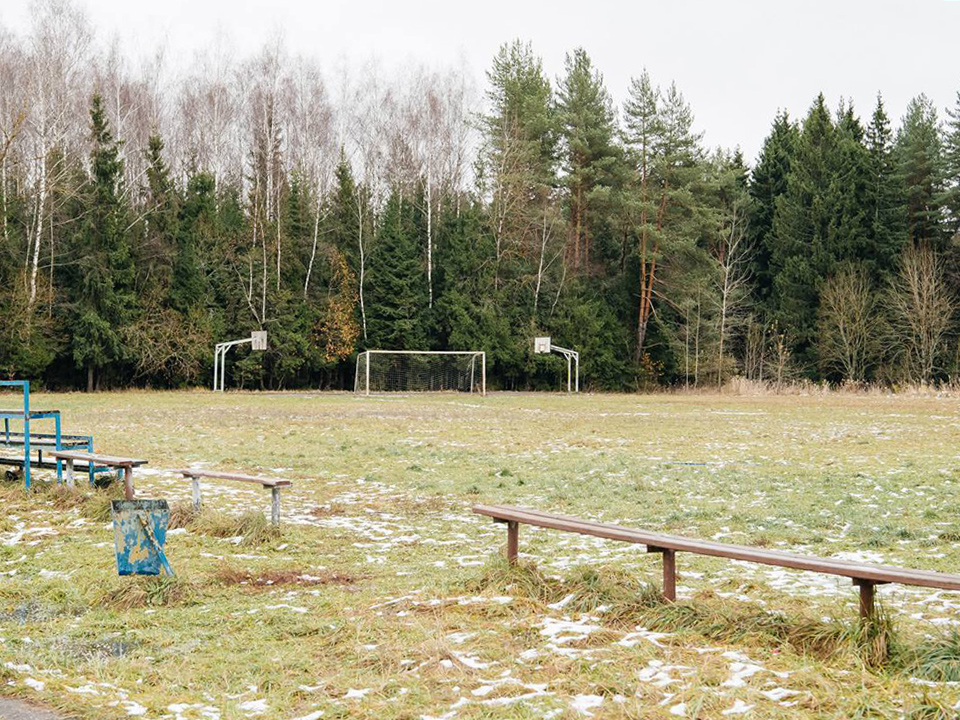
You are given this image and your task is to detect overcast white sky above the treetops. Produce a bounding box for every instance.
[0,0,960,159]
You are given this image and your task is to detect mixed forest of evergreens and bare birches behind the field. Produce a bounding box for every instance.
[0,0,960,390]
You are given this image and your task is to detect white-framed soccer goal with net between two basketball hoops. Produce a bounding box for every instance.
[353,350,487,395]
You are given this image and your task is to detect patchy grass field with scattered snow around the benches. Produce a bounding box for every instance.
[0,392,960,720]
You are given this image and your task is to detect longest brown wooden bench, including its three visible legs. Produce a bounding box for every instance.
[473,505,960,617]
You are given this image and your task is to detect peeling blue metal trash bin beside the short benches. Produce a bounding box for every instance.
[111,500,174,575]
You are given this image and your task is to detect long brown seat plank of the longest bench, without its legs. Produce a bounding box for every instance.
[473,505,960,590]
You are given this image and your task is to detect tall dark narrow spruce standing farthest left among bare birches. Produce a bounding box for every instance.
[72,95,136,391]
